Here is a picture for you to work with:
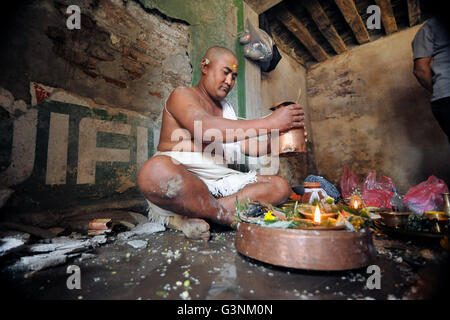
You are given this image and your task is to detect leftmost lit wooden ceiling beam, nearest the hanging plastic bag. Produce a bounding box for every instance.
[277,8,328,62]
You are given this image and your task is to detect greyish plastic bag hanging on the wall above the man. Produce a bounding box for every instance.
[239,19,273,61]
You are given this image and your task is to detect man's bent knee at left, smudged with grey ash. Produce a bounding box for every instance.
[137,156,183,200]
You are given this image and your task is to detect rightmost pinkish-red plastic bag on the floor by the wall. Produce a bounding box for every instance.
[403,175,448,214]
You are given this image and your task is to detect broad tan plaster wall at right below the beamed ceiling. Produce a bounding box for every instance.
[307,26,450,192]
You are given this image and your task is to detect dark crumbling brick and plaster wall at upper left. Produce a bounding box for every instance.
[0,0,192,120]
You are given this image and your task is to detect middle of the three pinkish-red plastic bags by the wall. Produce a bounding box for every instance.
[362,170,395,208]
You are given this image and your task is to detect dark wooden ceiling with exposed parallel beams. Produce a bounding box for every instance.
[245,0,424,67]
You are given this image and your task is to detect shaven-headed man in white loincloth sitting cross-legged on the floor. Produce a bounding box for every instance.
[138,47,304,239]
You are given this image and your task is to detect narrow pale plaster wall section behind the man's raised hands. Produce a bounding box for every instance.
[258,52,316,185]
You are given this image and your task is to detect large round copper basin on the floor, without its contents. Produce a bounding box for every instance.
[235,222,375,271]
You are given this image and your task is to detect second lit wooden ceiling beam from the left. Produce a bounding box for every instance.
[302,0,347,54]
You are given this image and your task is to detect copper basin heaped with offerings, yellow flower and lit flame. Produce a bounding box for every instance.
[235,197,375,270]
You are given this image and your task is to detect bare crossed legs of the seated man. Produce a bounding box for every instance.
[138,155,291,239]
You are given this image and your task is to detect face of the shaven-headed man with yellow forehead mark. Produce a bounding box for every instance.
[204,54,238,100]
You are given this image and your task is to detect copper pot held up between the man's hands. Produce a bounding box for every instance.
[270,101,306,157]
